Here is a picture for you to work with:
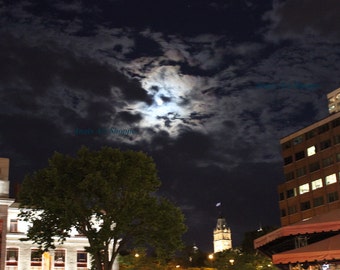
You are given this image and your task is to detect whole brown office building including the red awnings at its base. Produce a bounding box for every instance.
[254,88,340,269]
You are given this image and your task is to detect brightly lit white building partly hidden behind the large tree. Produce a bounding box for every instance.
[0,158,119,270]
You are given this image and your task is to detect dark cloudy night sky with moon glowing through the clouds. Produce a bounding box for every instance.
[0,0,340,251]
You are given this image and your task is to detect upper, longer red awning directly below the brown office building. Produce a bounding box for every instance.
[254,209,340,248]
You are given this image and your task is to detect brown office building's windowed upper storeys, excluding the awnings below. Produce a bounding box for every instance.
[278,88,340,226]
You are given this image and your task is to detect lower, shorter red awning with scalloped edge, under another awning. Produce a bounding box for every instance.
[272,234,340,264]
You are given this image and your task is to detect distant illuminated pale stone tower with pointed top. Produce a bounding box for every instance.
[214,217,232,253]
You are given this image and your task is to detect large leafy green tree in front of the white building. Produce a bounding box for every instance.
[19,147,186,270]
